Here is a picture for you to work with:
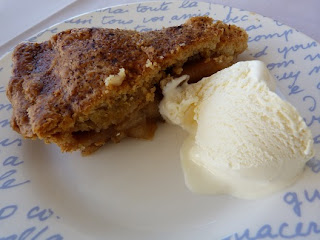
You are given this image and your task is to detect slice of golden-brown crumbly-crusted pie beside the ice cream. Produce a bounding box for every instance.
[7,17,248,155]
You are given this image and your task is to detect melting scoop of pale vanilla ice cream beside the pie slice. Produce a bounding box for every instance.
[160,61,314,199]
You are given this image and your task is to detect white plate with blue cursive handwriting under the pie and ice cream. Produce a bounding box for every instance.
[0,1,320,240]
